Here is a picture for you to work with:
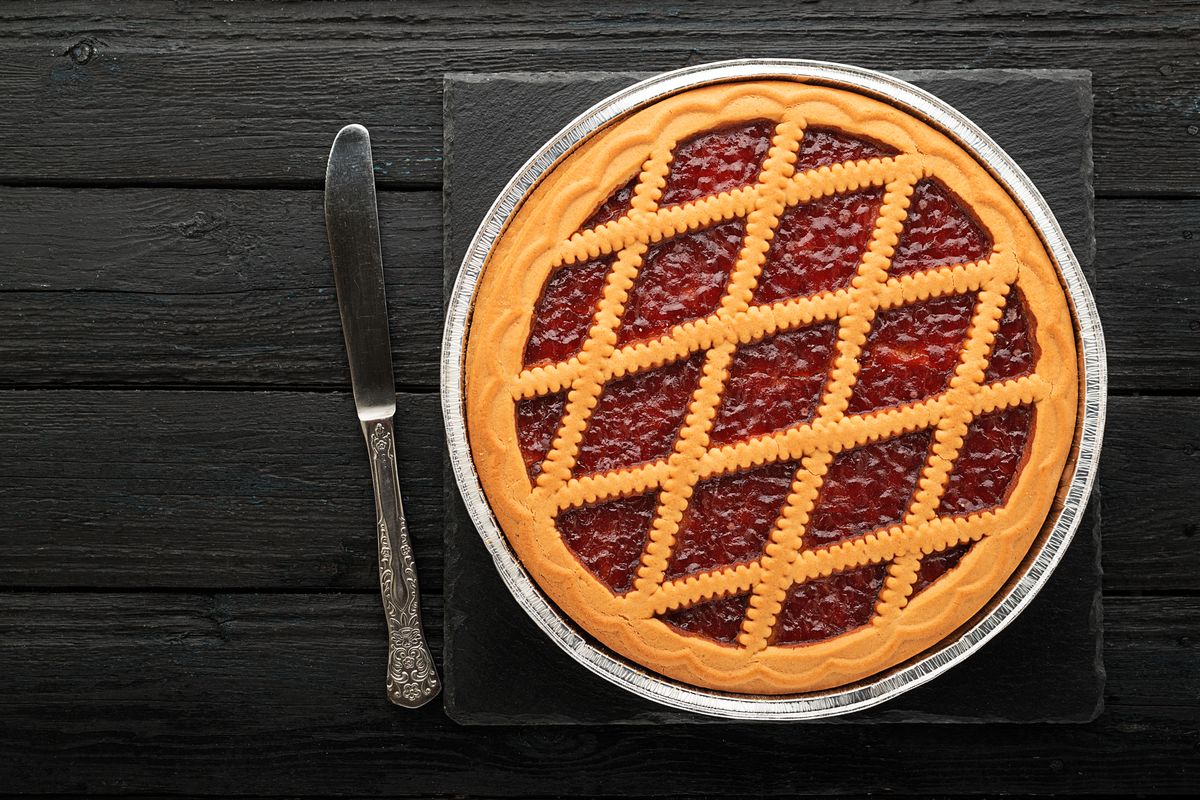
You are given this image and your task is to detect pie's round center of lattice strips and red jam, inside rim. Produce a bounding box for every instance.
[514,116,1045,649]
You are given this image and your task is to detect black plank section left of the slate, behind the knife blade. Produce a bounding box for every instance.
[0,188,442,387]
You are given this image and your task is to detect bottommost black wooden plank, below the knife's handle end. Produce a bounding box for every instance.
[0,593,1200,796]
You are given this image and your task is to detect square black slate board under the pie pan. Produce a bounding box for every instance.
[443,71,1104,724]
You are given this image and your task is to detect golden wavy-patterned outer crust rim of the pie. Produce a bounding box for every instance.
[464,80,1078,694]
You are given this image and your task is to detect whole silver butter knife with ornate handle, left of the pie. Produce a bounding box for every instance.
[325,125,442,709]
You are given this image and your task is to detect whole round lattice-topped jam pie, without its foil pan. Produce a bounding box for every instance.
[464,80,1079,694]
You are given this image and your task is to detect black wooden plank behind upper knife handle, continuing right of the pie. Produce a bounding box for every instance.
[0,391,1200,596]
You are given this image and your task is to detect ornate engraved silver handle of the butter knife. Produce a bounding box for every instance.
[362,417,442,709]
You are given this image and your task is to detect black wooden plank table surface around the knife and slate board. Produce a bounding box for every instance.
[0,0,1200,796]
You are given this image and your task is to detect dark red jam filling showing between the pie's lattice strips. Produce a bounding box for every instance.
[516,120,1036,646]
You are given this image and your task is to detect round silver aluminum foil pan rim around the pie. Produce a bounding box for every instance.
[442,59,1108,721]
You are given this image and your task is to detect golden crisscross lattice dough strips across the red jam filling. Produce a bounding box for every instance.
[511,110,1050,651]
